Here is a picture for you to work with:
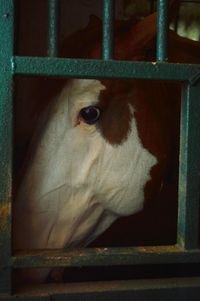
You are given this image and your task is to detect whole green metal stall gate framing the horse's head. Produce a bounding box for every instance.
[0,0,200,301]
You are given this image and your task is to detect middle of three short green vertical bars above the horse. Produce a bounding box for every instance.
[102,0,115,60]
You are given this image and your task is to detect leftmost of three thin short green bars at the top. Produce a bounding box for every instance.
[48,0,58,57]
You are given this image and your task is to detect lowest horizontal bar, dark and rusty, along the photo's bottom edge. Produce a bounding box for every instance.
[9,277,200,301]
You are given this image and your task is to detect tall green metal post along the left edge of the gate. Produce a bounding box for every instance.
[0,0,14,296]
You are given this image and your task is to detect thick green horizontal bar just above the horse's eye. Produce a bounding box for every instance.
[12,56,200,81]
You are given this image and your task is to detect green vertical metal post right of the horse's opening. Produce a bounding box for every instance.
[178,83,200,249]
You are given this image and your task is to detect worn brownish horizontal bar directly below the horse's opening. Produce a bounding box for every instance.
[11,246,200,268]
